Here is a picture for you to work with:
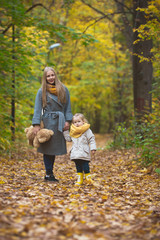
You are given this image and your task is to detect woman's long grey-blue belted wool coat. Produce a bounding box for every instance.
[32,87,73,155]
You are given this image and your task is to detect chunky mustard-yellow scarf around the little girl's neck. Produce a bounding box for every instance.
[70,123,90,138]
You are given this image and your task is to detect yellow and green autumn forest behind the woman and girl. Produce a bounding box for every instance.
[0,0,160,172]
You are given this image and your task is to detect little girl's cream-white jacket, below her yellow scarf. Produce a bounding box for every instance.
[63,128,96,161]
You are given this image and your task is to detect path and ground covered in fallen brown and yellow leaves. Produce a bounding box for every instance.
[0,135,160,240]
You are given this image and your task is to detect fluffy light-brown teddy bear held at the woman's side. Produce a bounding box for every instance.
[24,126,54,148]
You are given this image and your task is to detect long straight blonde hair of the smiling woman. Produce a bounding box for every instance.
[42,67,66,107]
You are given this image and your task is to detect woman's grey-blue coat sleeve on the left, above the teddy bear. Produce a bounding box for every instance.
[32,88,42,125]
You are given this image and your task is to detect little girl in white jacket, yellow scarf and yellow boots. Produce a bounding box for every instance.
[63,113,96,185]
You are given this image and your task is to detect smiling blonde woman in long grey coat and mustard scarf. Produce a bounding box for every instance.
[32,67,72,182]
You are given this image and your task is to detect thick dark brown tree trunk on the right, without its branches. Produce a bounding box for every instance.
[133,0,153,117]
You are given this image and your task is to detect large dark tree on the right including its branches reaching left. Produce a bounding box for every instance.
[81,0,153,119]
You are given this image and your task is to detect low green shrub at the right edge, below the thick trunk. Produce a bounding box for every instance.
[111,99,160,166]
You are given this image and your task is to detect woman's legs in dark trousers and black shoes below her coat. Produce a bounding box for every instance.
[43,154,58,181]
